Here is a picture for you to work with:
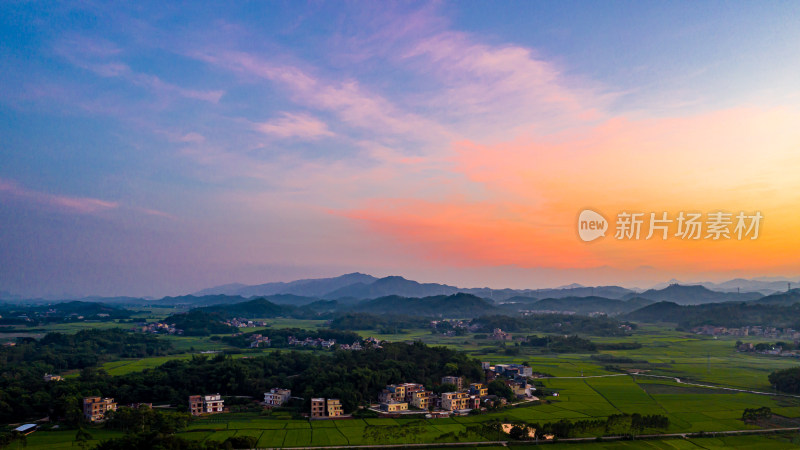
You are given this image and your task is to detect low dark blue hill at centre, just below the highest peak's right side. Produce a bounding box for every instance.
[351,293,497,318]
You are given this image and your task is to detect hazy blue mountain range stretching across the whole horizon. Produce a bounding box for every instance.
[5,273,800,315]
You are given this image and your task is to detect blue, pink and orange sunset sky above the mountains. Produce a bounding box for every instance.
[0,0,800,297]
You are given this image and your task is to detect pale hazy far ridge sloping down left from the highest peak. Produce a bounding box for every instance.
[195,272,377,297]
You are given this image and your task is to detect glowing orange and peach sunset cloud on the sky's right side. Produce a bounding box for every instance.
[346,108,800,271]
